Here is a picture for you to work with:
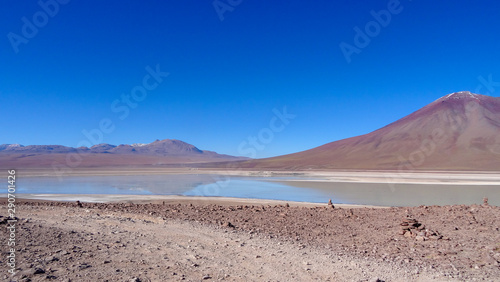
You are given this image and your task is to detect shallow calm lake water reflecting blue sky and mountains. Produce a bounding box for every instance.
[17,174,500,206]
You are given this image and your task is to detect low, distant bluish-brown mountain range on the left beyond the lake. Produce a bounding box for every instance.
[0,139,246,168]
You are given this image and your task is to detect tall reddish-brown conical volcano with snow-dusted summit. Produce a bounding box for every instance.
[239,91,500,171]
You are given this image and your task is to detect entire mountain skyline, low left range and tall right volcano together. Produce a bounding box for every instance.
[0,91,500,171]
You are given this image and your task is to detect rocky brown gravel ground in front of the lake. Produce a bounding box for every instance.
[0,200,500,281]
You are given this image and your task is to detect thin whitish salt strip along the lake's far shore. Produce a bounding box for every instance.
[12,167,500,185]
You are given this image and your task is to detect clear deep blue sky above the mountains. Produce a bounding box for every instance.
[0,0,500,157]
